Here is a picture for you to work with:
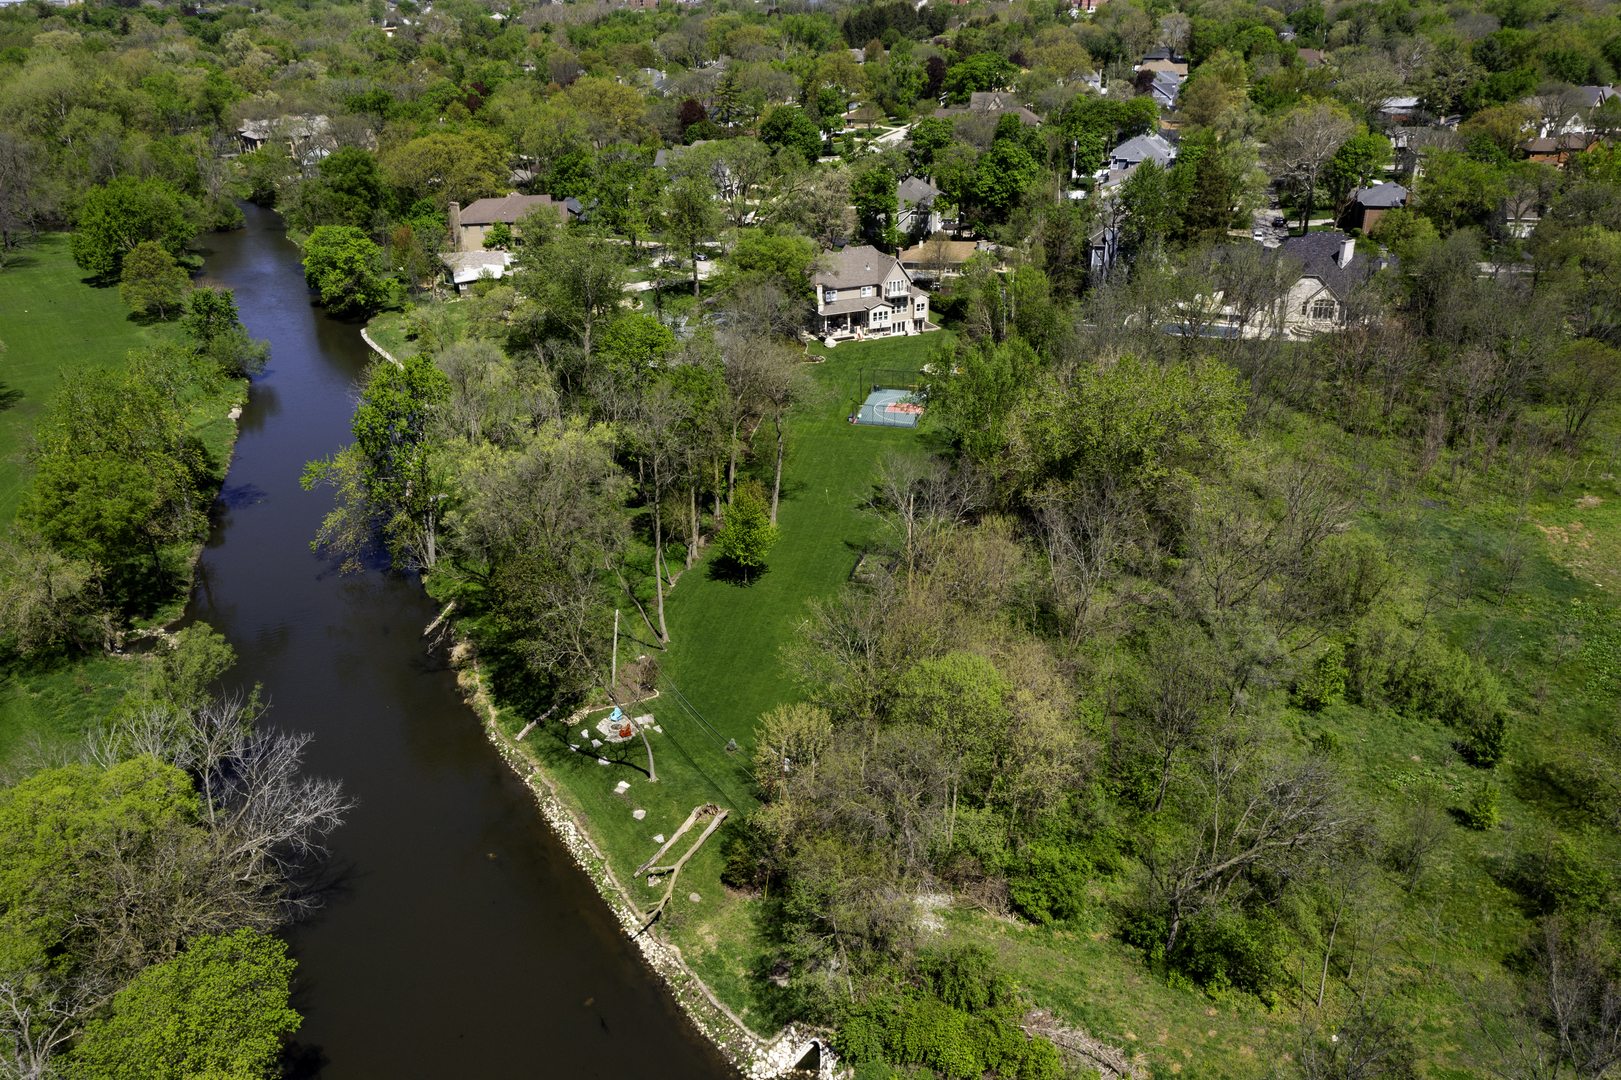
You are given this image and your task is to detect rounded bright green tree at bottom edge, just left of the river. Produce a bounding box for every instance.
[71,929,302,1080]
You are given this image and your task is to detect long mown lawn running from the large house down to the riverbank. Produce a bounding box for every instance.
[483,334,945,1031]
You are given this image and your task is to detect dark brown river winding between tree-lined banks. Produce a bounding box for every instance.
[188,206,736,1080]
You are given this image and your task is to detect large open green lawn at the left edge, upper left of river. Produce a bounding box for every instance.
[0,234,189,522]
